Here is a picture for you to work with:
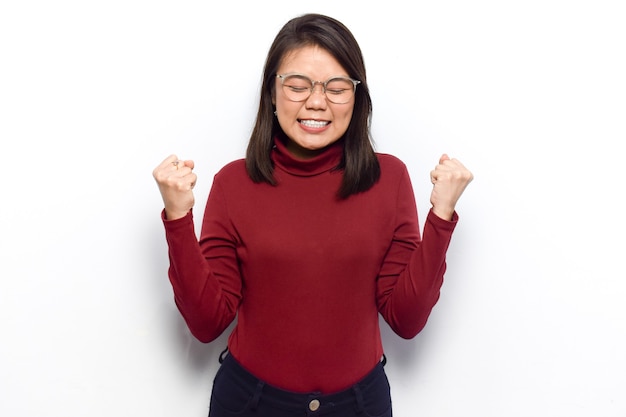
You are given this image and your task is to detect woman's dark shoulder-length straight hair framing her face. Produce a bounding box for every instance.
[246,14,380,199]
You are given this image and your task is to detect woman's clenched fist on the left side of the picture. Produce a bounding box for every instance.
[152,155,197,220]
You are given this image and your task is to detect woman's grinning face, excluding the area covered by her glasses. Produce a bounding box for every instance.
[273,46,354,158]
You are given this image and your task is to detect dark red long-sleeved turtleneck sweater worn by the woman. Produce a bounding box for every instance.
[164,137,457,393]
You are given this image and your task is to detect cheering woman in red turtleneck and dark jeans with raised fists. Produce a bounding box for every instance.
[153,14,472,417]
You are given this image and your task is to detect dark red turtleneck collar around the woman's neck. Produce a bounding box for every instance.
[272,137,343,177]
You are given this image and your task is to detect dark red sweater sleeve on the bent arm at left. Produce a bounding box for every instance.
[164,176,241,342]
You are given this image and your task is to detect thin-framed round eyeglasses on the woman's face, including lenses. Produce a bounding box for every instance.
[276,74,361,104]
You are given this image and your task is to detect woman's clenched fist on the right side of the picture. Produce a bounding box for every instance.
[430,154,474,220]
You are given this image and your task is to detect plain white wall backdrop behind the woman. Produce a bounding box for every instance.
[0,0,626,417]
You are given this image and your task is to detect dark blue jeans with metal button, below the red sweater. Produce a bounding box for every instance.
[209,355,392,417]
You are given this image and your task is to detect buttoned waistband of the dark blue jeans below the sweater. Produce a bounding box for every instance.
[220,354,386,416]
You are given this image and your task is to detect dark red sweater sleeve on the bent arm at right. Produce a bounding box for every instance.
[377,166,458,339]
